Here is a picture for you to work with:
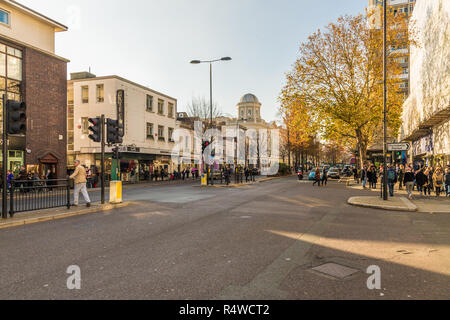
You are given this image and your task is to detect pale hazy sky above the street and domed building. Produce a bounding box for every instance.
[19,0,368,120]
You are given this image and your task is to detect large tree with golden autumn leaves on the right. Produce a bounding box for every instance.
[281,14,410,168]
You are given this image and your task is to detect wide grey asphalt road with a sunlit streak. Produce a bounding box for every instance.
[0,177,450,299]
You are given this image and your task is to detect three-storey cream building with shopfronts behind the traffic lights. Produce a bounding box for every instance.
[68,72,177,181]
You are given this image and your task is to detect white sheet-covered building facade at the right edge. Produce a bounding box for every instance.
[400,0,450,166]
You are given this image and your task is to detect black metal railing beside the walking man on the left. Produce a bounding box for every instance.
[9,179,70,217]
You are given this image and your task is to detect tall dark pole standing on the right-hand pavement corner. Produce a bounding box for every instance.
[383,0,388,200]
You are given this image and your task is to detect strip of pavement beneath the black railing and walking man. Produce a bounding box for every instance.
[0,201,133,229]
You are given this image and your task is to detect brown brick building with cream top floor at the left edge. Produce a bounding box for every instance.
[0,0,68,178]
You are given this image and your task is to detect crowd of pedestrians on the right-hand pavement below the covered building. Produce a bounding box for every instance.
[355,164,450,199]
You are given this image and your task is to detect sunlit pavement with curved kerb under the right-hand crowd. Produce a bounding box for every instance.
[347,180,450,214]
